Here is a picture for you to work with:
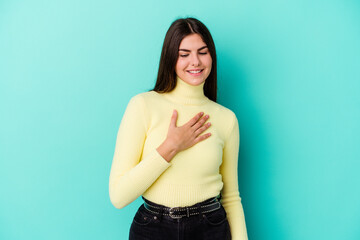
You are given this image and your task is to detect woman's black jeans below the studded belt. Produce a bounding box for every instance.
[129,197,231,240]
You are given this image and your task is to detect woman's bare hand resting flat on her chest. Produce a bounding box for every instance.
[157,110,211,162]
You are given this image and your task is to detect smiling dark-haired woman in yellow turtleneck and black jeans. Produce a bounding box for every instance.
[109,18,247,240]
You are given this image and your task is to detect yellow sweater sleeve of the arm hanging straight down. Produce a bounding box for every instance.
[220,112,248,240]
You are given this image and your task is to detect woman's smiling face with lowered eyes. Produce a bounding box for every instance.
[175,33,212,86]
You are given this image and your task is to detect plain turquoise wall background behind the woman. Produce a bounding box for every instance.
[0,0,360,240]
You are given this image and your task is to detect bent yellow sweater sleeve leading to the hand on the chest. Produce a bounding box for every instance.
[109,94,171,208]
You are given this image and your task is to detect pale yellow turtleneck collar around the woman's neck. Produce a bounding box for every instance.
[164,76,209,105]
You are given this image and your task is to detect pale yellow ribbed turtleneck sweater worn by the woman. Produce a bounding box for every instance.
[109,77,247,240]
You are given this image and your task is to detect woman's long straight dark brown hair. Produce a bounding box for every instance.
[149,18,217,102]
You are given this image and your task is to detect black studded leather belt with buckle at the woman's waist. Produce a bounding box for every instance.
[144,197,221,219]
